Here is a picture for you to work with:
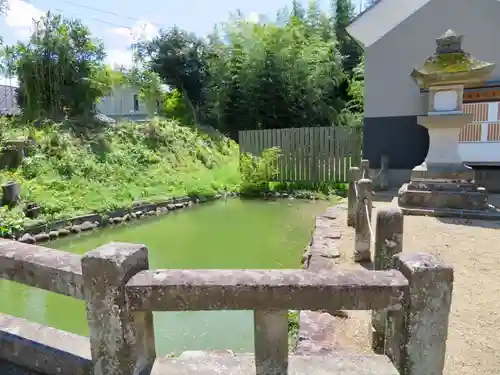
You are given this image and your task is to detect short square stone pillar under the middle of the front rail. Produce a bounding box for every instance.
[254,310,288,375]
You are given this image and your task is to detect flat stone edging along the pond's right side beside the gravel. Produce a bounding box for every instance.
[295,204,347,355]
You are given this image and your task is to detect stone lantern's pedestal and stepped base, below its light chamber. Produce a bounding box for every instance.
[398,114,500,218]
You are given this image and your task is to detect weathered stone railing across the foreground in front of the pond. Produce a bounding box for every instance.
[0,232,453,375]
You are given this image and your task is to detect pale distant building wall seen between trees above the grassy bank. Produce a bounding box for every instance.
[97,87,148,116]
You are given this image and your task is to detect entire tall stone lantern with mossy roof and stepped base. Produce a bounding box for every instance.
[398,30,499,217]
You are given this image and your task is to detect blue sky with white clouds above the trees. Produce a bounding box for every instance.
[0,0,361,85]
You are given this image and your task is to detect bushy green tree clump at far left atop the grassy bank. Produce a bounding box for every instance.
[7,12,111,120]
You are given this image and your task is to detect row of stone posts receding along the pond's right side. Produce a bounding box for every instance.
[347,164,453,374]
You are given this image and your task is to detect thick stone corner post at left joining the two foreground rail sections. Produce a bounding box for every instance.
[82,243,156,375]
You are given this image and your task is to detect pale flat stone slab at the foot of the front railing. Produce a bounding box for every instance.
[151,352,399,375]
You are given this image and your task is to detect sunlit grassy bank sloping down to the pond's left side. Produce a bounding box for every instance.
[0,120,240,233]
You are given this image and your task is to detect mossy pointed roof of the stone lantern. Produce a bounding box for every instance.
[411,30,495,88]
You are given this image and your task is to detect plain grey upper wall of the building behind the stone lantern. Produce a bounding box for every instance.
[365,0,500,117]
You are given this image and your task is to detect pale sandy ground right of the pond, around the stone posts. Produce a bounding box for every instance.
[334,195,500,375]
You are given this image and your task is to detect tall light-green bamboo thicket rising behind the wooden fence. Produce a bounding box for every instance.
[201,1,344,137]
